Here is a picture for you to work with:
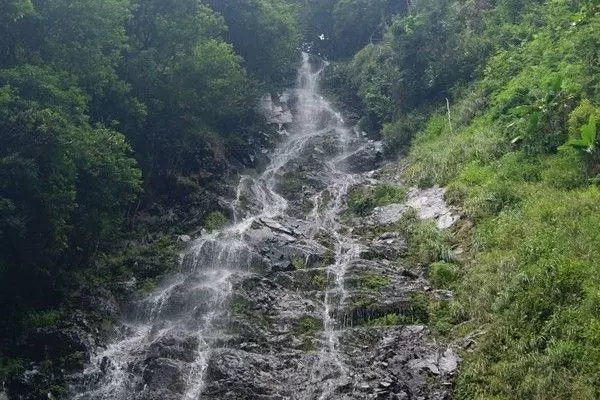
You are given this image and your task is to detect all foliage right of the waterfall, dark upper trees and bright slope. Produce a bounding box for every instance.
[316,0,600,399]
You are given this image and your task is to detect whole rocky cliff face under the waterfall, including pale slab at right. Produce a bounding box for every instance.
[64,56,459,400]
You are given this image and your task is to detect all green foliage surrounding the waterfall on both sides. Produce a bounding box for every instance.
[0,0,600,399]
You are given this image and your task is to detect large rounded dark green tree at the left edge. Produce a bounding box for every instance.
[0,65,140,332]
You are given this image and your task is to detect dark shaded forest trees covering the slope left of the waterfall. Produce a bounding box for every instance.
[0,0,299,380]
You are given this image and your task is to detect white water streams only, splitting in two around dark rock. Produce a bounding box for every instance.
[72,54,370,400]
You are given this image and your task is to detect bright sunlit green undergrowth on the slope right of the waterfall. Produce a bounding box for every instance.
[404,2,600,400]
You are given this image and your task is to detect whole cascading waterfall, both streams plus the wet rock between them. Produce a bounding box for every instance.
[71,54,454,400]
